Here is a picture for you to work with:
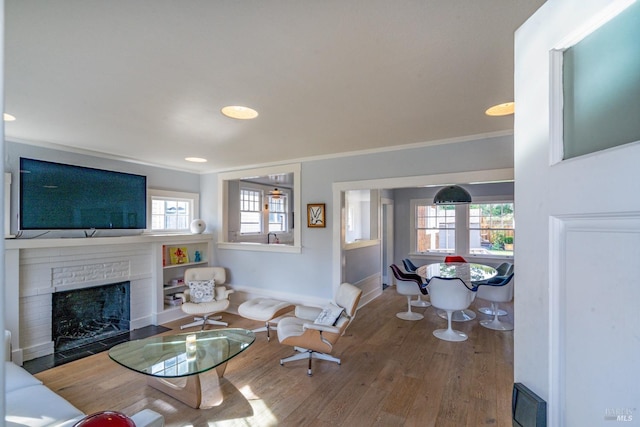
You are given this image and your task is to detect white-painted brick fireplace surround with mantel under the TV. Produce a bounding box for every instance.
[5,236,192,364]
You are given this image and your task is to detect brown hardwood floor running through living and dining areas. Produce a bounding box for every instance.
[36,287,513,427]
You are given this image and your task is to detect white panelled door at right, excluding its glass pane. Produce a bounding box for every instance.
[514,0,640,427]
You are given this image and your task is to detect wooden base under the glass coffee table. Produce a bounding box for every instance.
[147,363,227,409]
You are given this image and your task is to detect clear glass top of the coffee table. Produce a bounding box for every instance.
[109,328,256,378]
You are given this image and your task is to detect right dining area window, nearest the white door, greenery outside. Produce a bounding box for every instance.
[469,202,515,256]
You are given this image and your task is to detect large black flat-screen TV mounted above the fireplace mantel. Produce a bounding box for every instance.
[20,158,147,230]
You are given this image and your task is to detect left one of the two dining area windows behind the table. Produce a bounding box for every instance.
[414,203,456,253]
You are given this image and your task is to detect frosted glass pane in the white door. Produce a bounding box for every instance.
[552,2,640,159]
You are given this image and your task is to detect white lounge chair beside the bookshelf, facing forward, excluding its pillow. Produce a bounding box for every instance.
[178,267,233,329]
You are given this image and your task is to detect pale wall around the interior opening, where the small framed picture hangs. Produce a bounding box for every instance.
[200,135,513,300]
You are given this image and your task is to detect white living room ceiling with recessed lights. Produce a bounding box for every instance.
[5,0,544,172]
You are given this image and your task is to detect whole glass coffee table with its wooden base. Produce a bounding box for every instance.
[109,328,256,409]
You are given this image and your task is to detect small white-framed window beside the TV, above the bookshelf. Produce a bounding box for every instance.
[148,189,199,233]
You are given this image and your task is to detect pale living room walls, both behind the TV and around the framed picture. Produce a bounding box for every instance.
[5,135,513,301]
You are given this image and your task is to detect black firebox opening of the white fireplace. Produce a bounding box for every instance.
[51,282,131,352]
